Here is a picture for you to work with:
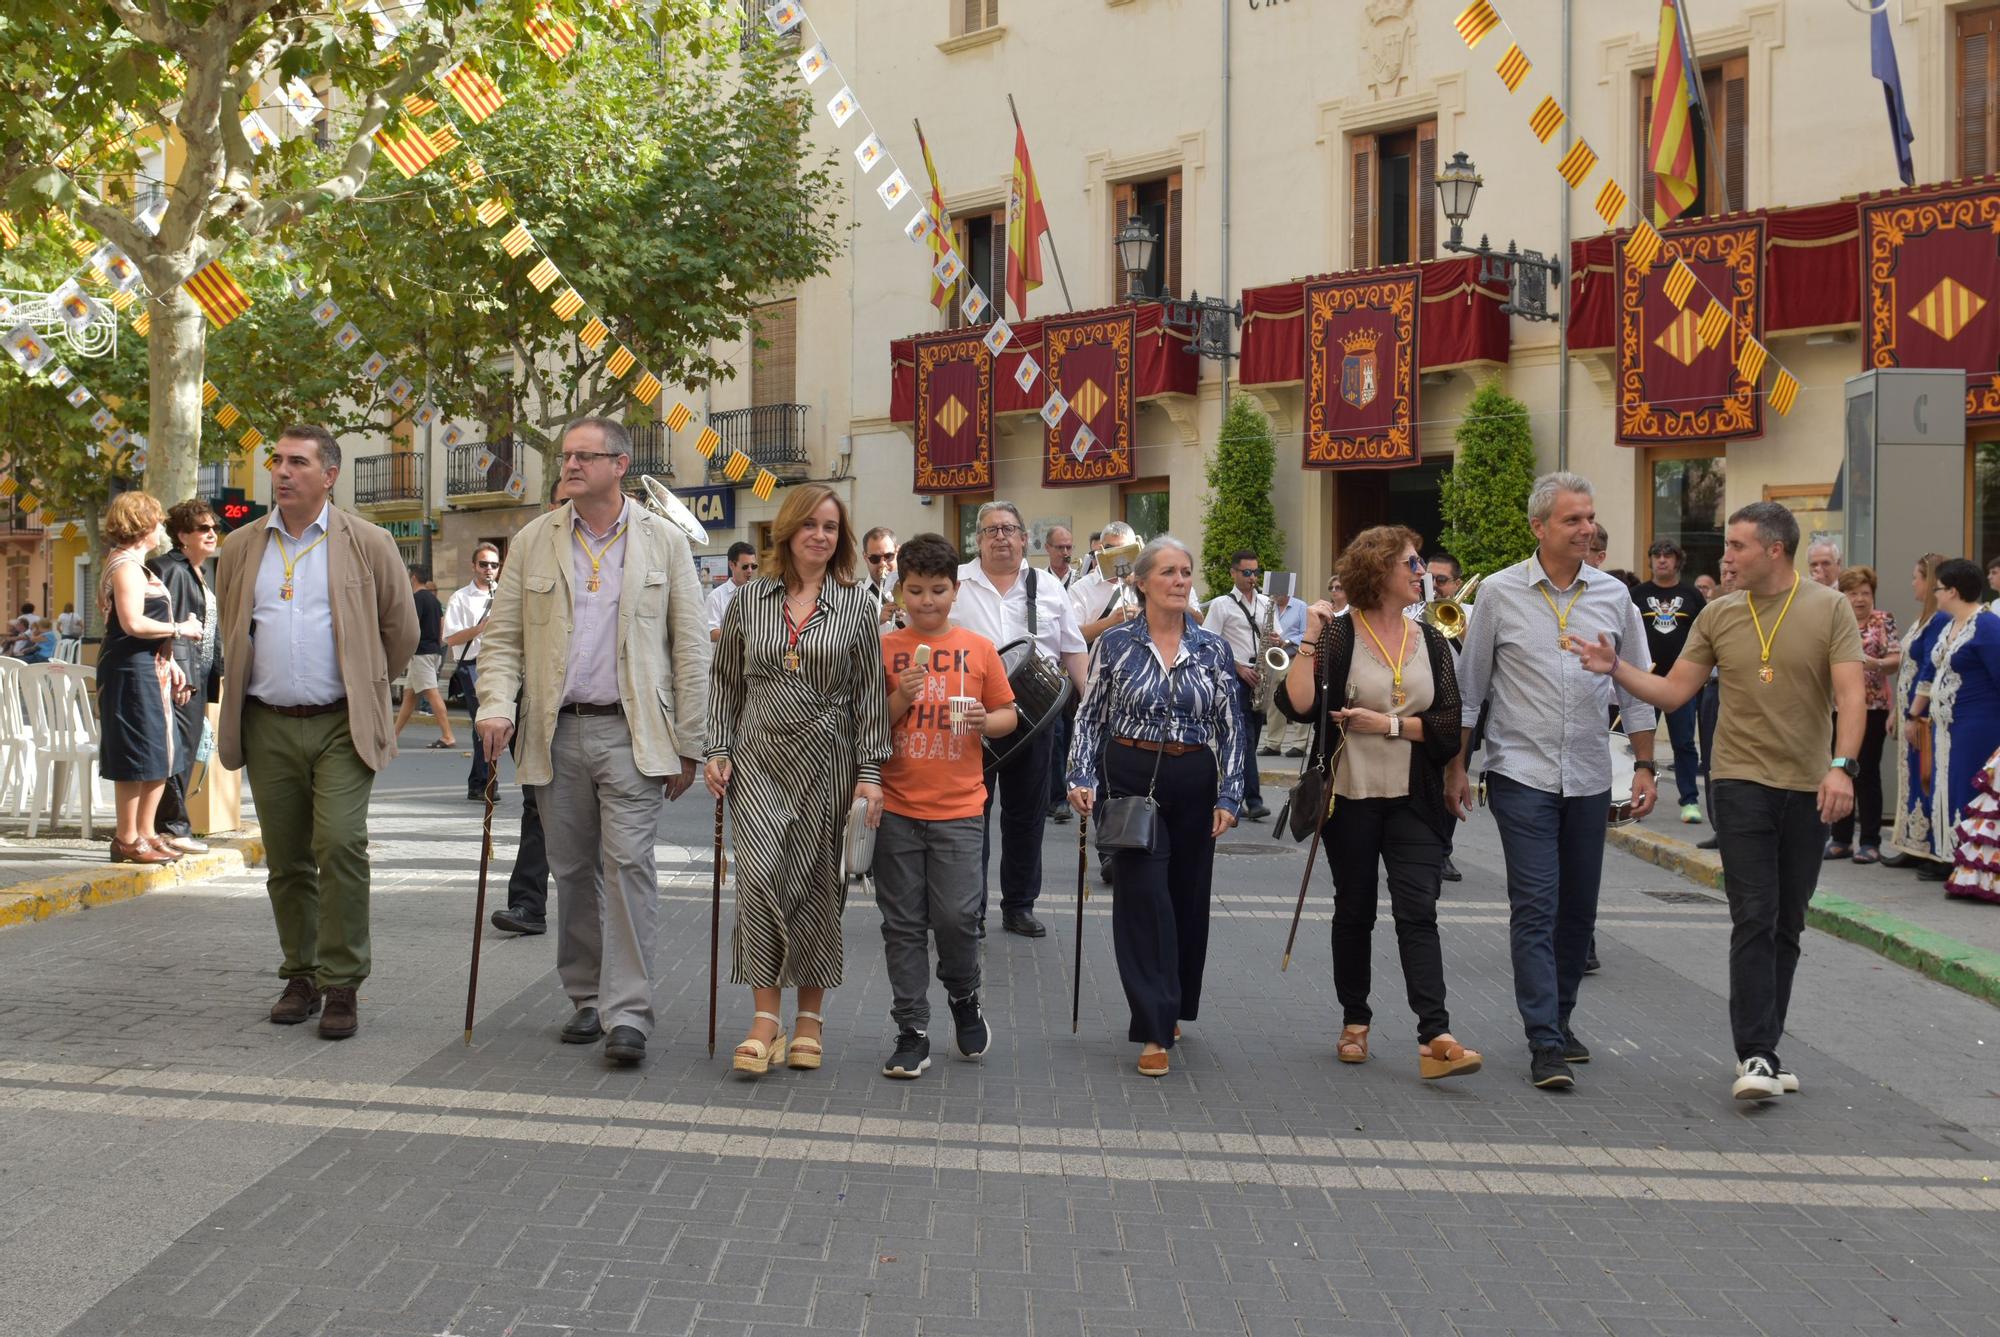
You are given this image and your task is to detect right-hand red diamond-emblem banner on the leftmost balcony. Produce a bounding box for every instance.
[1042,306,1136,488]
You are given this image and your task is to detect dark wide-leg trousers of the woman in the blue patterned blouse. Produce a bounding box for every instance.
[1104,743,1216,1049]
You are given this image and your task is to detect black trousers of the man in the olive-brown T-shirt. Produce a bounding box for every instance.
[1714,781,1826,1059]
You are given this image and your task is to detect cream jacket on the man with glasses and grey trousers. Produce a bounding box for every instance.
[478,502,710,785]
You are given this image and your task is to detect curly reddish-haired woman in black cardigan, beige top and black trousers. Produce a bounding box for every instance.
[1276,524,1480,1081]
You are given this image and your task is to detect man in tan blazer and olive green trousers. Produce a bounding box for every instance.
[216,424,416,1039]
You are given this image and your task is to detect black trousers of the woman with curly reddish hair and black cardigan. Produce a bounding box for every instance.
[1324,799,1452,1045]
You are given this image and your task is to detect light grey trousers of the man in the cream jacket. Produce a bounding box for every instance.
[538,715,666,1035]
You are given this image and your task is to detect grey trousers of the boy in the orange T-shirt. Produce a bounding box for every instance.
[874,813,986,1031]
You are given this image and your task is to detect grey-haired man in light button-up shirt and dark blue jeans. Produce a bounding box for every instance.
[1444,472,1656,1089]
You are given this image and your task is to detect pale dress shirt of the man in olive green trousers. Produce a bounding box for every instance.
[248,502,348,707]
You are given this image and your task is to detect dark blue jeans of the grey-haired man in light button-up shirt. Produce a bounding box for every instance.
[1486,771,1612,1045]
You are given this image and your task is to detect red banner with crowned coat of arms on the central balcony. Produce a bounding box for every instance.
[1306,266,1418,468]
